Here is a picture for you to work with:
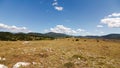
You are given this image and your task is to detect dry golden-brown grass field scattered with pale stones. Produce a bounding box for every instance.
[0,38,120,68]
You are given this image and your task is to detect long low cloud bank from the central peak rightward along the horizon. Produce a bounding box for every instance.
[44,25,104,36]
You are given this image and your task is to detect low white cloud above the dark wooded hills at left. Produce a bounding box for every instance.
[0,23,30,32]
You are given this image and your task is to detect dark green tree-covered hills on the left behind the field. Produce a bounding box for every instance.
[0,32,54,41]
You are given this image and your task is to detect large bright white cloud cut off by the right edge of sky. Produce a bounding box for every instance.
[101,13,120,28]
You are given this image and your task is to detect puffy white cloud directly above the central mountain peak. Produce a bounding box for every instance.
[47,25,85,35]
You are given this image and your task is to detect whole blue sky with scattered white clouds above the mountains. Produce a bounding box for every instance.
[0,0,120,35]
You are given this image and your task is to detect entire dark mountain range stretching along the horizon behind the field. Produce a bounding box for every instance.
[0,32,120,41]
